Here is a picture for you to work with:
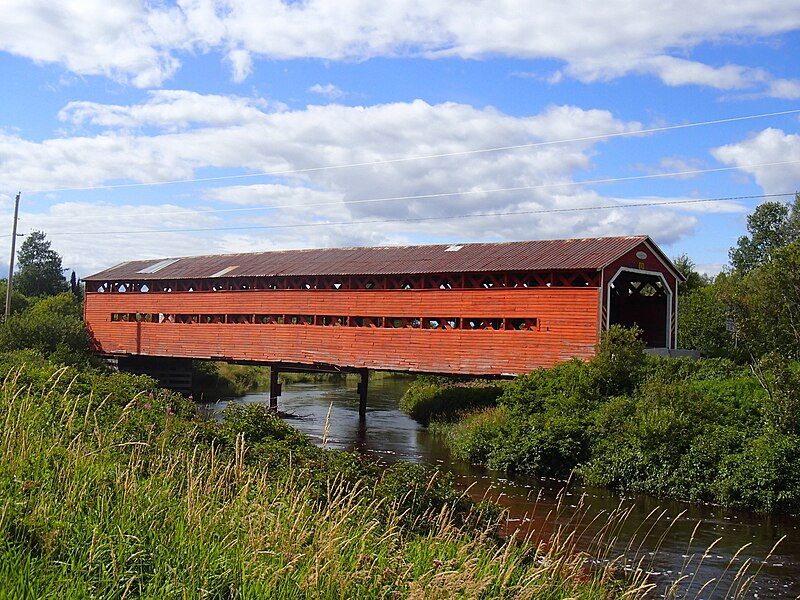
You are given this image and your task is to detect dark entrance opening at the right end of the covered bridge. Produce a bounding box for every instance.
[608,271,669,348]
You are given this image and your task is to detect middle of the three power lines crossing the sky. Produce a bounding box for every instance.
[25,160,800,217]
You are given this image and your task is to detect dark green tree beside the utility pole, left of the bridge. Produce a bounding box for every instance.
[14,231,68,296]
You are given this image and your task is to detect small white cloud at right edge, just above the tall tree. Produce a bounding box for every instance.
[711,127,800,194]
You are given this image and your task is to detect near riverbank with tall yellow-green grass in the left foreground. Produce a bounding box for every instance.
[0,353,644,598]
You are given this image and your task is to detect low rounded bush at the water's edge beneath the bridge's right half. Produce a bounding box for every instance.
[400,378,503,425]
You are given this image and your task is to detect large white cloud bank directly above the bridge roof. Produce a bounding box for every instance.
[0,91,731,273]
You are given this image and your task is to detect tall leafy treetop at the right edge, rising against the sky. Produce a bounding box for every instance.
[728,193,800,273]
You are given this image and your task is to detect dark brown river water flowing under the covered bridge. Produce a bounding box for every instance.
[211,378,800,598]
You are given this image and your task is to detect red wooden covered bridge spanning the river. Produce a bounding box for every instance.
[85,236,681,410]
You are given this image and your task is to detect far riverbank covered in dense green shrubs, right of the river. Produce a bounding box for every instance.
[404,332,800,513]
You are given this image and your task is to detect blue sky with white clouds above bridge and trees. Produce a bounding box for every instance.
[0,0,800,276]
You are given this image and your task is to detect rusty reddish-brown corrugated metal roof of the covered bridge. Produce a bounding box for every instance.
[85,235,663,281]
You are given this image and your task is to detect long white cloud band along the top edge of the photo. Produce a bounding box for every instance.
[0,0,800,98]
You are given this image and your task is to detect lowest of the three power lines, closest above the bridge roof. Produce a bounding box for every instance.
[29,192,795,237]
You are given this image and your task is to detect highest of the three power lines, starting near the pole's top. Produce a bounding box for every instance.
[20,109,800,194]
